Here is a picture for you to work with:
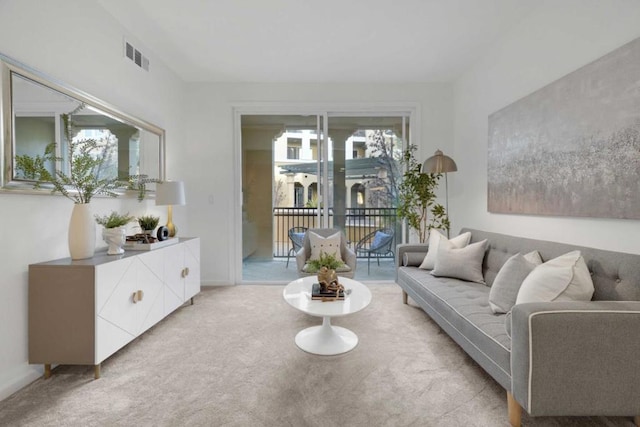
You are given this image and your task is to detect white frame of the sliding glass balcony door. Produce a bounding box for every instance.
[229,101,422,284]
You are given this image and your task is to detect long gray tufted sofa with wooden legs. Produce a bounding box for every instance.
[396,229,640,426]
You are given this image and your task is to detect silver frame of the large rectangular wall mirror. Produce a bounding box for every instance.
[0,53,166,196]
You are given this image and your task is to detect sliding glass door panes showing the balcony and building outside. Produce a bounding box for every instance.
[241,112,410,281]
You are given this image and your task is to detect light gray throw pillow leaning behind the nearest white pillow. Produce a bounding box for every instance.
[489,251,542,313]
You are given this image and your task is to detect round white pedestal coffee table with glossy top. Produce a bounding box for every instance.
[283,276,371,356]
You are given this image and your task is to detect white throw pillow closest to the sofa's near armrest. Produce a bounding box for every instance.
[516,251,594,304]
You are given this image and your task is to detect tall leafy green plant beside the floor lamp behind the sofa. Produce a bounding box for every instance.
[398,145,451,243]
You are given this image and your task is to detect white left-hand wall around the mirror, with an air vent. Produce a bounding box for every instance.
[0,0,185,399]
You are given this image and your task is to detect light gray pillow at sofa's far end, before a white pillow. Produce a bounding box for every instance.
[431,239,487,283]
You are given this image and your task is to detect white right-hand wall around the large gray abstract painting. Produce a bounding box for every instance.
[449,0,640,253]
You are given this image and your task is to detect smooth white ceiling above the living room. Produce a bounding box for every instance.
[97,0,537,83]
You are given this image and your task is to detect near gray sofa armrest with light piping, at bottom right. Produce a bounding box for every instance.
[511,301,640,416]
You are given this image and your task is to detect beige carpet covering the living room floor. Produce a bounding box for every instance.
[0,284,632,426]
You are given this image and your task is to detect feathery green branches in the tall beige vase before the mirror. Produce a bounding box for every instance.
[15,110,146,203]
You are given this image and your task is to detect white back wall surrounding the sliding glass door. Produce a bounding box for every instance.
[184,83,453,284]
